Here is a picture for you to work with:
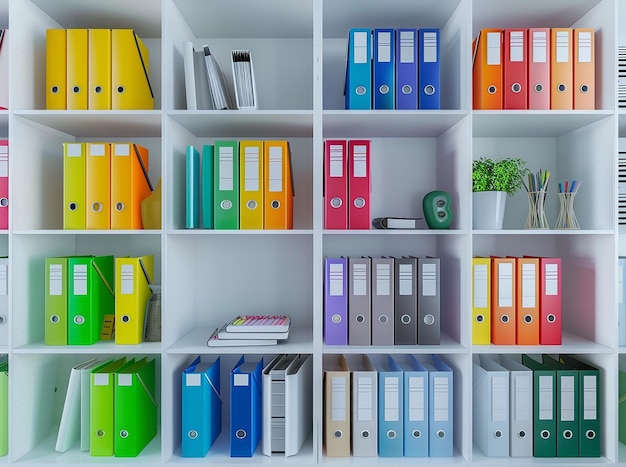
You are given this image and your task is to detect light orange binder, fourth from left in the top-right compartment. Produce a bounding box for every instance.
[550,28,574,110]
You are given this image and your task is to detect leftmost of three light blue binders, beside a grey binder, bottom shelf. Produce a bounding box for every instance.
[372,355,404,457]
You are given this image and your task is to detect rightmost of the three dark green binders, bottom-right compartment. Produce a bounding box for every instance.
[559,355,602,457]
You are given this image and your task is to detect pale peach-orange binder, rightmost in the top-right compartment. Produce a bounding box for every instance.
[574,28,596,110]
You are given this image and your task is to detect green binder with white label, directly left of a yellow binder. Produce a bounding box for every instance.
[213,141,239,230]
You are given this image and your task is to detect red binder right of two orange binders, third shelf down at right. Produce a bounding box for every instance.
[539,257,562,345]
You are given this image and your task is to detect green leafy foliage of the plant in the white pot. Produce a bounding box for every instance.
[472,157,530,196]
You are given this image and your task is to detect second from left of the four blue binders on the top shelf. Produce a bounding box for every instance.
[372,29,396,110]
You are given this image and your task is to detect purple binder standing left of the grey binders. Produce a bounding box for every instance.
[324,258,348,345]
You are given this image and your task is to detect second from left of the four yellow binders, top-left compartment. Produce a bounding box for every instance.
[67,29,89,110]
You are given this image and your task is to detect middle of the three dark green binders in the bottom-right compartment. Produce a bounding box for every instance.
[543,355,581,457]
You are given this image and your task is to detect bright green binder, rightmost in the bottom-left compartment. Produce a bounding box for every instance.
[115,358,158,457]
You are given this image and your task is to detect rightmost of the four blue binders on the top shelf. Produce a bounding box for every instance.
[418,29,441,110]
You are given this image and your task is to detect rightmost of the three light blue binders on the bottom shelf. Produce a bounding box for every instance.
[424,355,454,457]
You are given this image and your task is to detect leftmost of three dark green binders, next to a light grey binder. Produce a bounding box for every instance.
[522,355,556,457]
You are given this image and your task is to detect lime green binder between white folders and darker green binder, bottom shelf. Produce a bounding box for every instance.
[89,357,135,456]
